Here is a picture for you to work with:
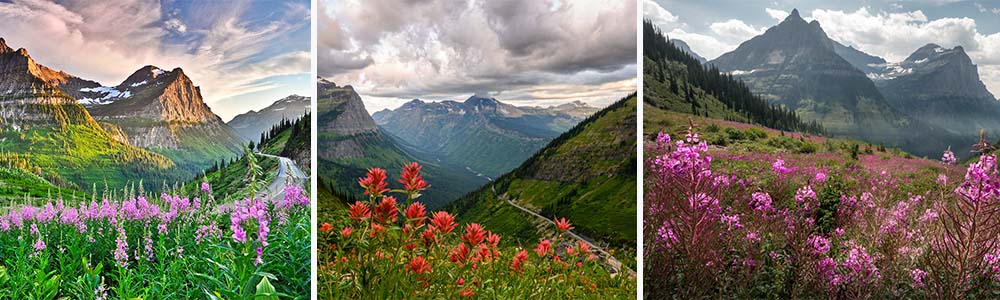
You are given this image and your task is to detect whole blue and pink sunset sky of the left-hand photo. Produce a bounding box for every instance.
[0,0,313,121]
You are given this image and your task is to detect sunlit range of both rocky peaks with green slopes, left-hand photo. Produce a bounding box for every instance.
[0,38,294,190]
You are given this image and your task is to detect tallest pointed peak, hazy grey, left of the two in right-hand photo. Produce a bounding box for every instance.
[709,10,951,155]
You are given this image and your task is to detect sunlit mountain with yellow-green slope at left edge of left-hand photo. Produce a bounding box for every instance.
[0,38,176,187]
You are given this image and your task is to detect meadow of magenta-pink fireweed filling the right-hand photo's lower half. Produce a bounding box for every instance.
[643,125,1000,299]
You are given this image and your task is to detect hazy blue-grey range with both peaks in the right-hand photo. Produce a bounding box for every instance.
[707,10,976,156]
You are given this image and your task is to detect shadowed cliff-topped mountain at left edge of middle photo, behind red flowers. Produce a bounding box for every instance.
[316,78,487,209]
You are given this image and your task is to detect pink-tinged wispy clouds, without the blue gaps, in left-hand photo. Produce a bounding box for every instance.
[0,0,310,119]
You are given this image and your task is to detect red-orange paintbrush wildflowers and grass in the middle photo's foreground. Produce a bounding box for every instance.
[318,163,636,299]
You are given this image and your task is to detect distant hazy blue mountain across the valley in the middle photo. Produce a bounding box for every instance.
[372,96,595,178]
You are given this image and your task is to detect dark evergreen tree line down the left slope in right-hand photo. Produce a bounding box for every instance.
[642,20,823,134]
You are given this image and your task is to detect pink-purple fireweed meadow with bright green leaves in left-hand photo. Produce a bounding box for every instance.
[0,183,311,299]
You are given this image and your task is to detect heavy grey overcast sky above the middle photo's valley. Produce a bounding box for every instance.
[317,0,637,113]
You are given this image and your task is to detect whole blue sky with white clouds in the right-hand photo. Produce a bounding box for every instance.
[640,0,1000,96]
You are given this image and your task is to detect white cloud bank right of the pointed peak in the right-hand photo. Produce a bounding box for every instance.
[812,7,1000,94]
